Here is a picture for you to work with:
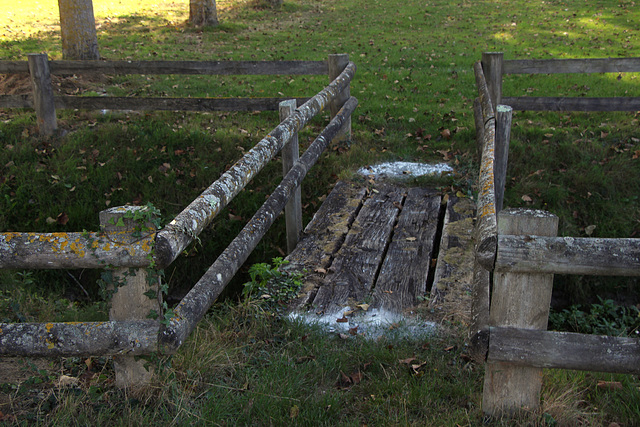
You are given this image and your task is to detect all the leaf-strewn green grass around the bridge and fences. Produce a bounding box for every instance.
[0,0,640,425]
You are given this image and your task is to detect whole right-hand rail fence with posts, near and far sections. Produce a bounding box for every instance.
[470,53,640,416]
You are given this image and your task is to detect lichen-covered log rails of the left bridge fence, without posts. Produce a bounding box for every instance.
[0,59,357,372]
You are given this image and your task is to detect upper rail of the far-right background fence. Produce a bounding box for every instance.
[503,58,640,74]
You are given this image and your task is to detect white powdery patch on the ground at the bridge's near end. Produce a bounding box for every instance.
[289,307,437,340]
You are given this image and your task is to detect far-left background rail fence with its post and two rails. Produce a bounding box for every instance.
[0,54,350,135]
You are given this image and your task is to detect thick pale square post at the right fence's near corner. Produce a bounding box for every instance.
[482,209,558,417]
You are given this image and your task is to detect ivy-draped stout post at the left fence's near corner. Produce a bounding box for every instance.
[100,206,161,388]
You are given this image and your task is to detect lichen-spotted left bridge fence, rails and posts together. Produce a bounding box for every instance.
[0,55,358,387]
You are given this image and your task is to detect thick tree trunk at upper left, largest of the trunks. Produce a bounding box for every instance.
[58,0,100,59]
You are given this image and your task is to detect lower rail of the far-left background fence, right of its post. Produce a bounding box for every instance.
[55,96,309,111]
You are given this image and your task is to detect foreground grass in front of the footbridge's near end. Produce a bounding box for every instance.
[1,301,640,426]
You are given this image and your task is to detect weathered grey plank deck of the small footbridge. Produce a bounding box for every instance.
[287,182,474,321]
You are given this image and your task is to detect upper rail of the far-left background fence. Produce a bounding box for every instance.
[45,61,329,75]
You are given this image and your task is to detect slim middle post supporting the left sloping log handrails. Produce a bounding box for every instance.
[278,99,302,253]
